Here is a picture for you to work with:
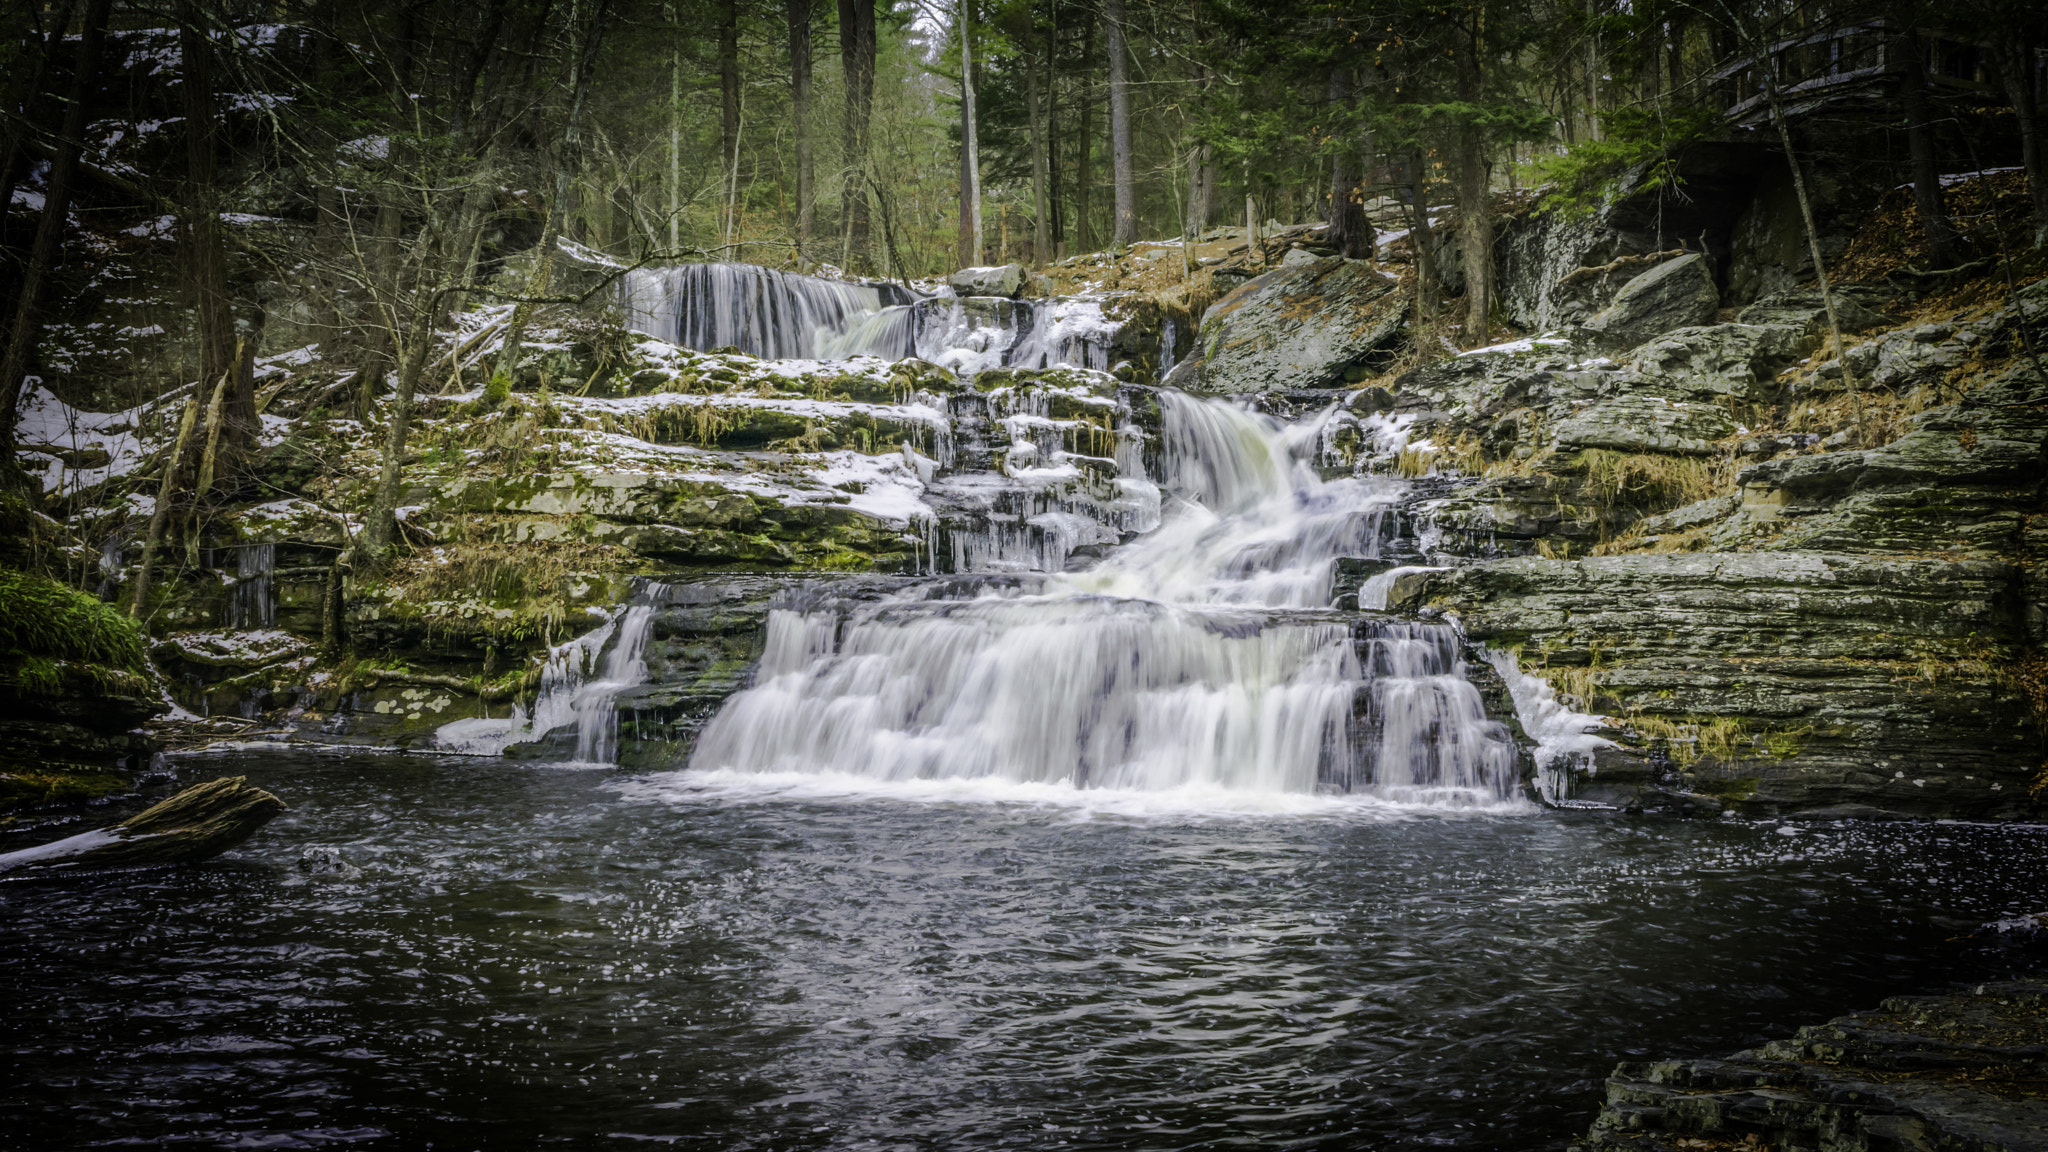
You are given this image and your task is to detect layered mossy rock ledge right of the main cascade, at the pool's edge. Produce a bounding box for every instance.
[1401,553,2048,818]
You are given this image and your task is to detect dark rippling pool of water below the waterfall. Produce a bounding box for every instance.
[0,752,2048,1150]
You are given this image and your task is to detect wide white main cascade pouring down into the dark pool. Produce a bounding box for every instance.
[690,394,1518,808]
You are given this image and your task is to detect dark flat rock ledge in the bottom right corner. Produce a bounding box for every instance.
[1573,982,2048,1152]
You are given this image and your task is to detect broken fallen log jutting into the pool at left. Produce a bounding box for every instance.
[0,777,285,873]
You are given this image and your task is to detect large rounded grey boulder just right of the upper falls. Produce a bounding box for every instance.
[1202,258,1411,392]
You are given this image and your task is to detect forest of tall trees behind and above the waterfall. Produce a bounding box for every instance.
[0,0,2048,500]
